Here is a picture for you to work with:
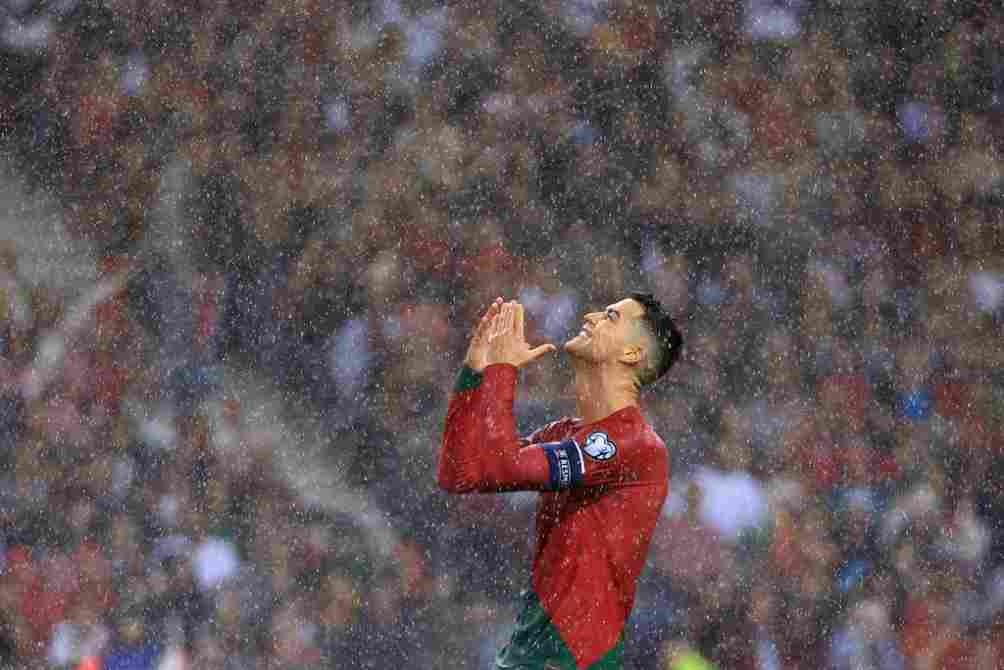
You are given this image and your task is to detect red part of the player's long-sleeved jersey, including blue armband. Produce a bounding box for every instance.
[439,365,669,668]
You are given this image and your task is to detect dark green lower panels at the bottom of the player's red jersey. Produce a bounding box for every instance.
[495,591,624,670]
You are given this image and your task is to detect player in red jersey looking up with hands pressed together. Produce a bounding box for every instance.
[439,293,683,670]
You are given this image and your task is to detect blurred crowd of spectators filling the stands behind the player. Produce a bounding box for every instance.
[0,0,1004,670]
